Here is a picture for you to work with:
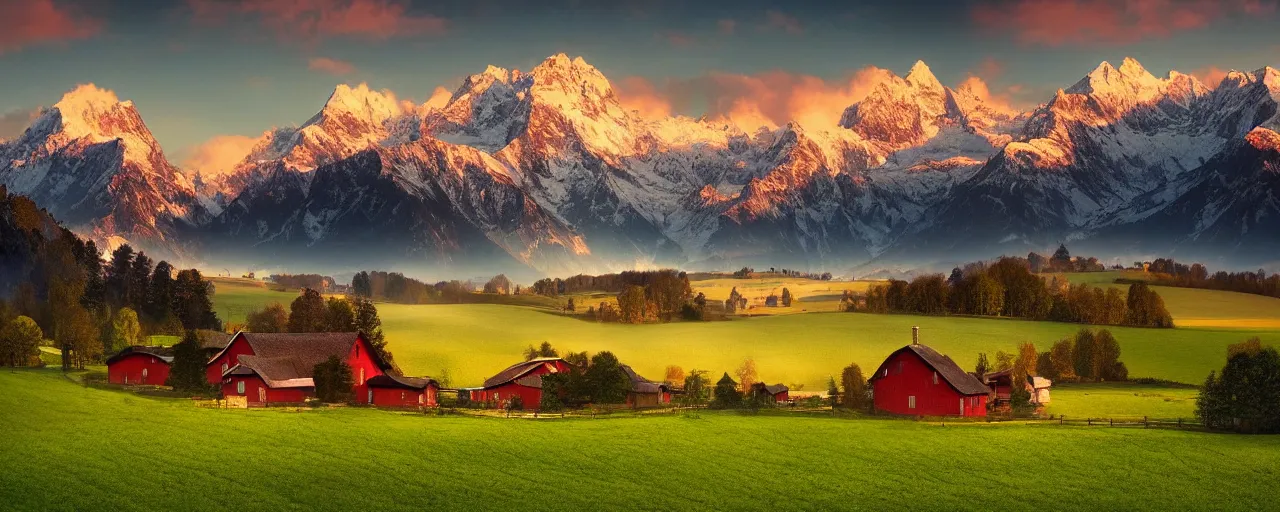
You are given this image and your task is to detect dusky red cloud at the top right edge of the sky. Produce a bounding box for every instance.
[972,0,1275,46]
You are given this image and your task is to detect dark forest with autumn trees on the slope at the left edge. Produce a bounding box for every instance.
[0,187,221,369]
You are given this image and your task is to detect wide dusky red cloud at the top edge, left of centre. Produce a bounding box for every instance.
[187,0,448,42]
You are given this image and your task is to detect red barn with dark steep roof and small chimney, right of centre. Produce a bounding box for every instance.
[870,343,991,416]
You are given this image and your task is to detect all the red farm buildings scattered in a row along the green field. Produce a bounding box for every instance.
[106,329,1052,416]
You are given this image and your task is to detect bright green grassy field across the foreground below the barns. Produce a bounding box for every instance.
[0,370,1280,511]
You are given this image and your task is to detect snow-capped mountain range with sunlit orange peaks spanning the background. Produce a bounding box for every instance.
[0,55,1280,275]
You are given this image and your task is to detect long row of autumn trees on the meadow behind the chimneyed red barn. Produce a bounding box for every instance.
[842,257,1174,328]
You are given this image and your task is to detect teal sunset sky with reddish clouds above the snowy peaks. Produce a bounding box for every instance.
[0,0,1280,174]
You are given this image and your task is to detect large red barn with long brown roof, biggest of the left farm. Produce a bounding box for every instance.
[206,332,390,403]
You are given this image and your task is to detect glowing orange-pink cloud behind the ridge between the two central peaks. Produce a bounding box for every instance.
[616,67,892,131]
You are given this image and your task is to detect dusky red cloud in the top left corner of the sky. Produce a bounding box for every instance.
[0,0,102,54]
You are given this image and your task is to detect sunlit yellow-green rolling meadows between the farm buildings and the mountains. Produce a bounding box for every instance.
[214,273,1280,390]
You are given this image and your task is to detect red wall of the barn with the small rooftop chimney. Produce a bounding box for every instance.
[874,351,987,416]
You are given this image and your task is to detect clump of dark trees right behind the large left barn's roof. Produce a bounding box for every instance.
[244,288,396,365]
